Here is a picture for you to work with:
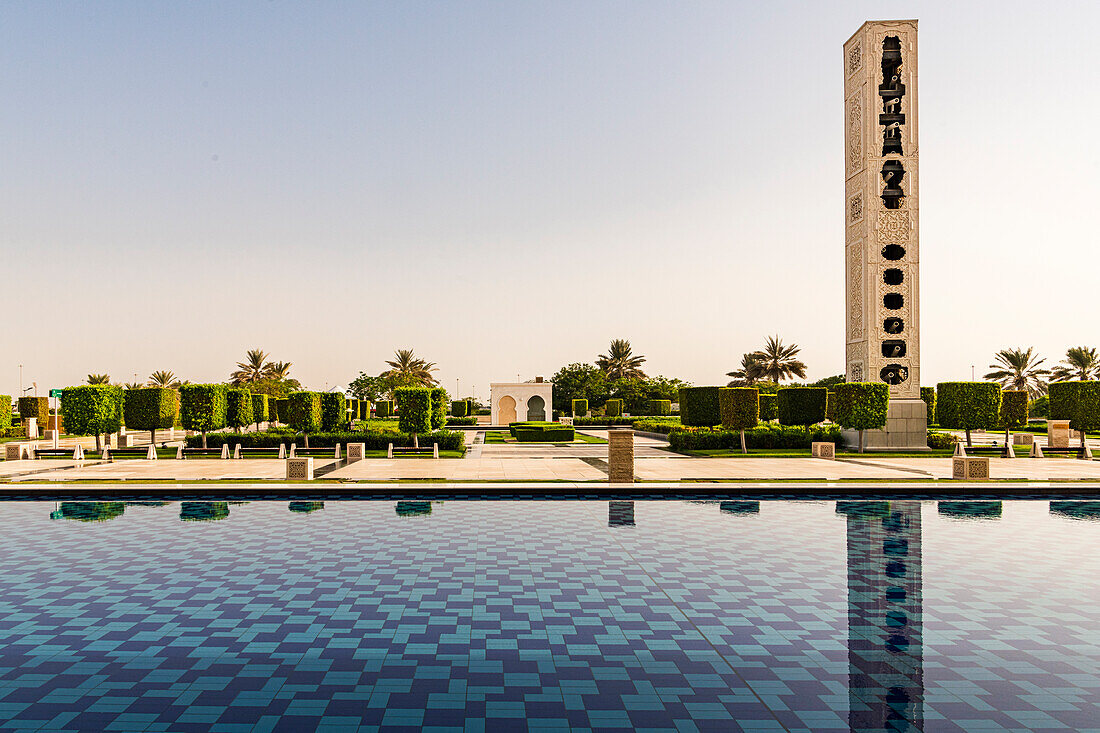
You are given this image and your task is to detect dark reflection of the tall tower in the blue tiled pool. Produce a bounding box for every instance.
[836,501,924,731]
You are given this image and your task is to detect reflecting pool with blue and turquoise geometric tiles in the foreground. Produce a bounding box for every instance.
[0,500,1100,732]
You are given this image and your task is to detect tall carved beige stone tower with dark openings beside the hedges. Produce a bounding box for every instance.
[844,20,927,450]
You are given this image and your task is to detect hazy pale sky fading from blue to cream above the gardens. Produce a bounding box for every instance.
[0,0,1100,398]
